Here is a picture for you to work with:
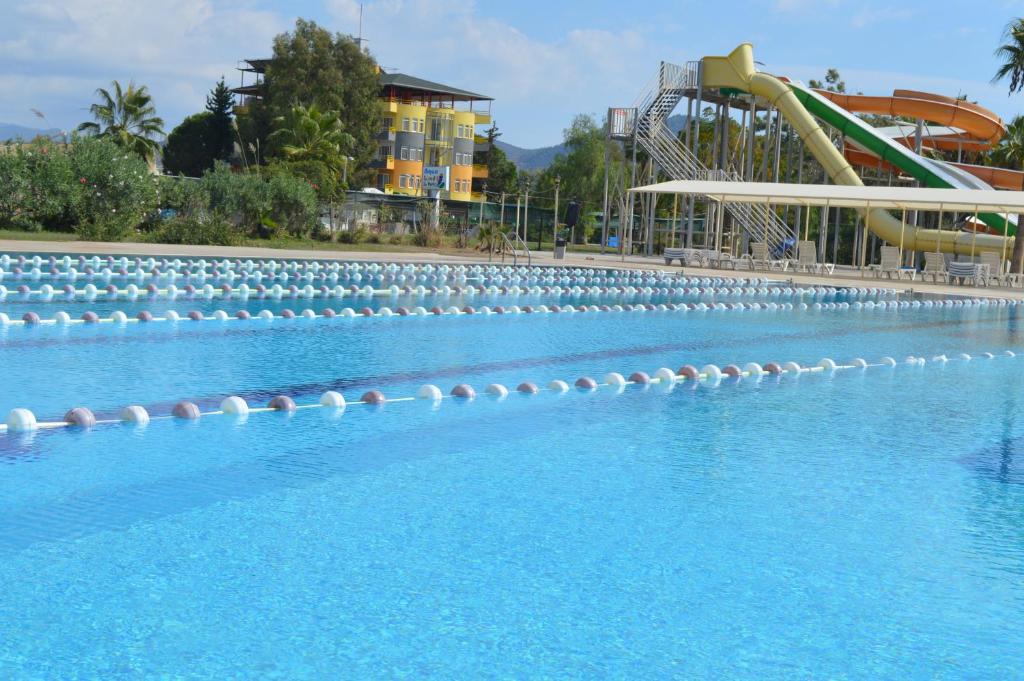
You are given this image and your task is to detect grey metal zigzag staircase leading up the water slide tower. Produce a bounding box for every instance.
[636,61,792,252]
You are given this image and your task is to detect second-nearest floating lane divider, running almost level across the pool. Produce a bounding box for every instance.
[0,298,1024,328]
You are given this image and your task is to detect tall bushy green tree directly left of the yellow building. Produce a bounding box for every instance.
[251,18,380,182]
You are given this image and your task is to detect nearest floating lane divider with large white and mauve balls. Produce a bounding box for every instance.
[0,350,1017,433]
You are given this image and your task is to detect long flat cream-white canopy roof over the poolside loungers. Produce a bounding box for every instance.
[630,180,1024,213]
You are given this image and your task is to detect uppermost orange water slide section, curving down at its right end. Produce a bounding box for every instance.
[815,90,1007,146]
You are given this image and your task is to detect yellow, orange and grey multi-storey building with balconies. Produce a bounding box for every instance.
[373,73,493,201]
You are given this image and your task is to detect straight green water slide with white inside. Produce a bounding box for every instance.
[788,82,1017,235]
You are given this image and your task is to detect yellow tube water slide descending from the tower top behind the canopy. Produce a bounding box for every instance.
[703,43,1013,255]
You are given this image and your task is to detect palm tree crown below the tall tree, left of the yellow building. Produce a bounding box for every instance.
[268,104,355,173]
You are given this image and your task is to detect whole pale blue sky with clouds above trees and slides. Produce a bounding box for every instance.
[6,0,1024,147]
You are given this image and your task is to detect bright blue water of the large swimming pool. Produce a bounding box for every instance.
[0,251,1024,678]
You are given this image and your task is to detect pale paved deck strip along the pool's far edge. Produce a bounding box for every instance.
[0,240,1024,299]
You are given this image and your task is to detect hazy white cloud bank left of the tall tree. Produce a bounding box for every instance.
[0,0,291,128]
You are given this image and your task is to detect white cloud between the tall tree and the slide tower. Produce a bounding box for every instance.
[327,0,655,144]
